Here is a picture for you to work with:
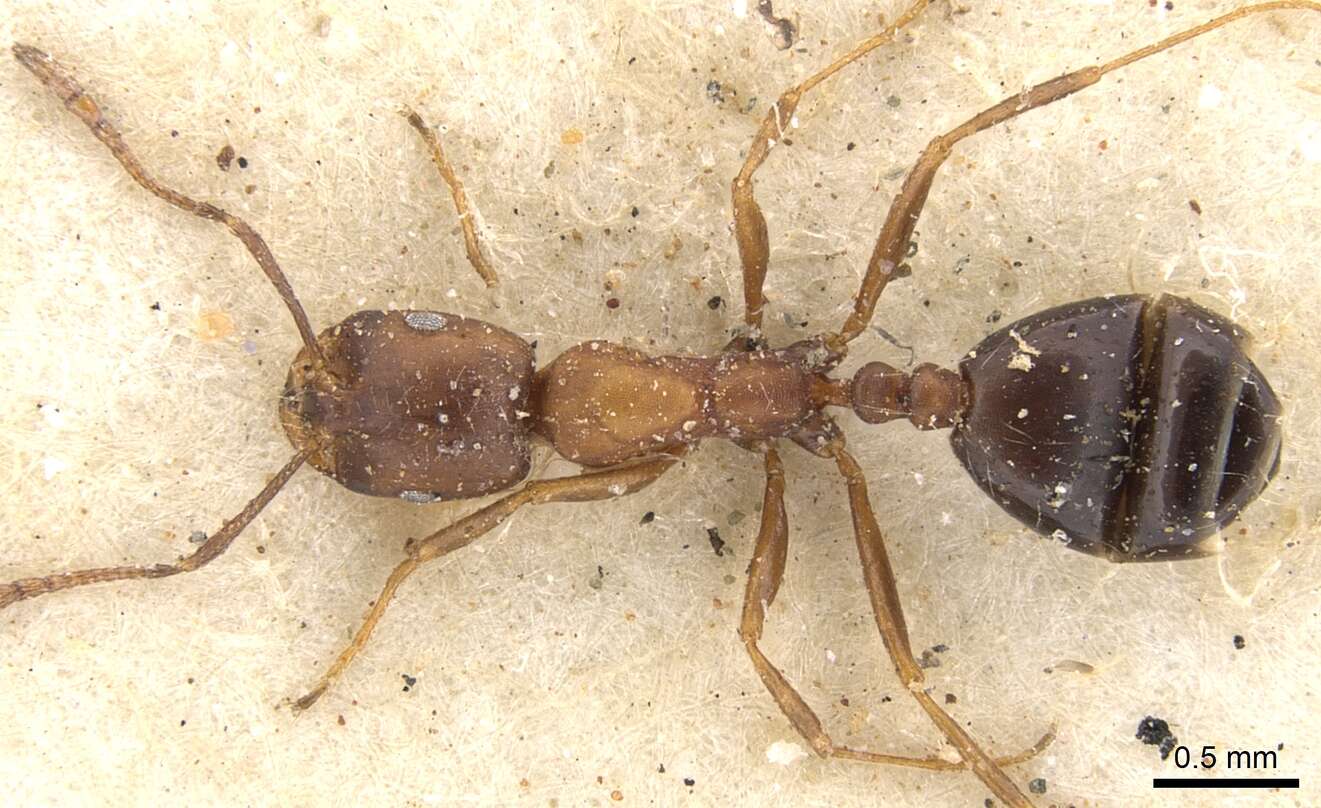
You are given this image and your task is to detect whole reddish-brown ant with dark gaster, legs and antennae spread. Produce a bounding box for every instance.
[0,0,1321,805]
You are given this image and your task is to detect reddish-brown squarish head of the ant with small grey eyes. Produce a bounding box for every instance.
[280,312,532,502]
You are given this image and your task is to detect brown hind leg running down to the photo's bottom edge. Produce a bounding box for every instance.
[828,438,1053,808]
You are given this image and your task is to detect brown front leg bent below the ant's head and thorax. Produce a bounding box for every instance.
[291,453,682,713]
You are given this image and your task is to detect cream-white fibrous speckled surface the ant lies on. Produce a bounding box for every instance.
[0,0,1321,805]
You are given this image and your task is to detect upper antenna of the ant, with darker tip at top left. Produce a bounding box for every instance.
[13,44,325,364]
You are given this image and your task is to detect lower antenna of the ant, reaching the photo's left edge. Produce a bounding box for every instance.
[0,452,309,609]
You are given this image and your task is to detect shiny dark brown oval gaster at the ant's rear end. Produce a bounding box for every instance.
[951,294,1280,561]
